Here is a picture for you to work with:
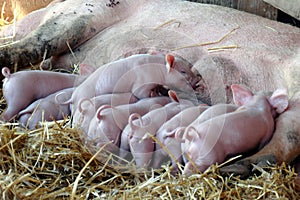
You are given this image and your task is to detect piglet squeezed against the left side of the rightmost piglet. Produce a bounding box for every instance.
[152,105,208,173]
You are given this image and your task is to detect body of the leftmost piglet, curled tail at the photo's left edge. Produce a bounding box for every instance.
[2,67,78,121]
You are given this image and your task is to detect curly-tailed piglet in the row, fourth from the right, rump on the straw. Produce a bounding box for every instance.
[85,97,171,153]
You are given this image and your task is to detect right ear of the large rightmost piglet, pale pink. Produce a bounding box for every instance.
[269,89,289,114]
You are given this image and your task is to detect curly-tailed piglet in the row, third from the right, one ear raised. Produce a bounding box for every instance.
[119,91,194,168]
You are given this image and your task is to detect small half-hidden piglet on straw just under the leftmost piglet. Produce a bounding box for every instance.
[18,88,74,130]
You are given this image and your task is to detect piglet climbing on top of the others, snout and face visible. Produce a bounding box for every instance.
[70,54,199,108]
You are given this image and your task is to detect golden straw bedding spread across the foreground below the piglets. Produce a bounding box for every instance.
[0,108,300,199]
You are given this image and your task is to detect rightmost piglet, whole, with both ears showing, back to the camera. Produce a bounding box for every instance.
[176,84,288,175]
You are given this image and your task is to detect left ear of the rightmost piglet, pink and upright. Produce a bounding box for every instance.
[231,84,253,106]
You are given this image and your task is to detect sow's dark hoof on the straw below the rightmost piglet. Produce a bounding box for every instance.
[220,164,250,178]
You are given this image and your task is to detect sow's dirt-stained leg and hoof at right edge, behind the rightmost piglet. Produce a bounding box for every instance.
[220,92,300,178]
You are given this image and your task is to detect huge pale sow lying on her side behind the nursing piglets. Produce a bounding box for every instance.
[0,0,300,177]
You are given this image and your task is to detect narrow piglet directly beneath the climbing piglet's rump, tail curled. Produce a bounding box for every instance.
[72,93,138,133]
